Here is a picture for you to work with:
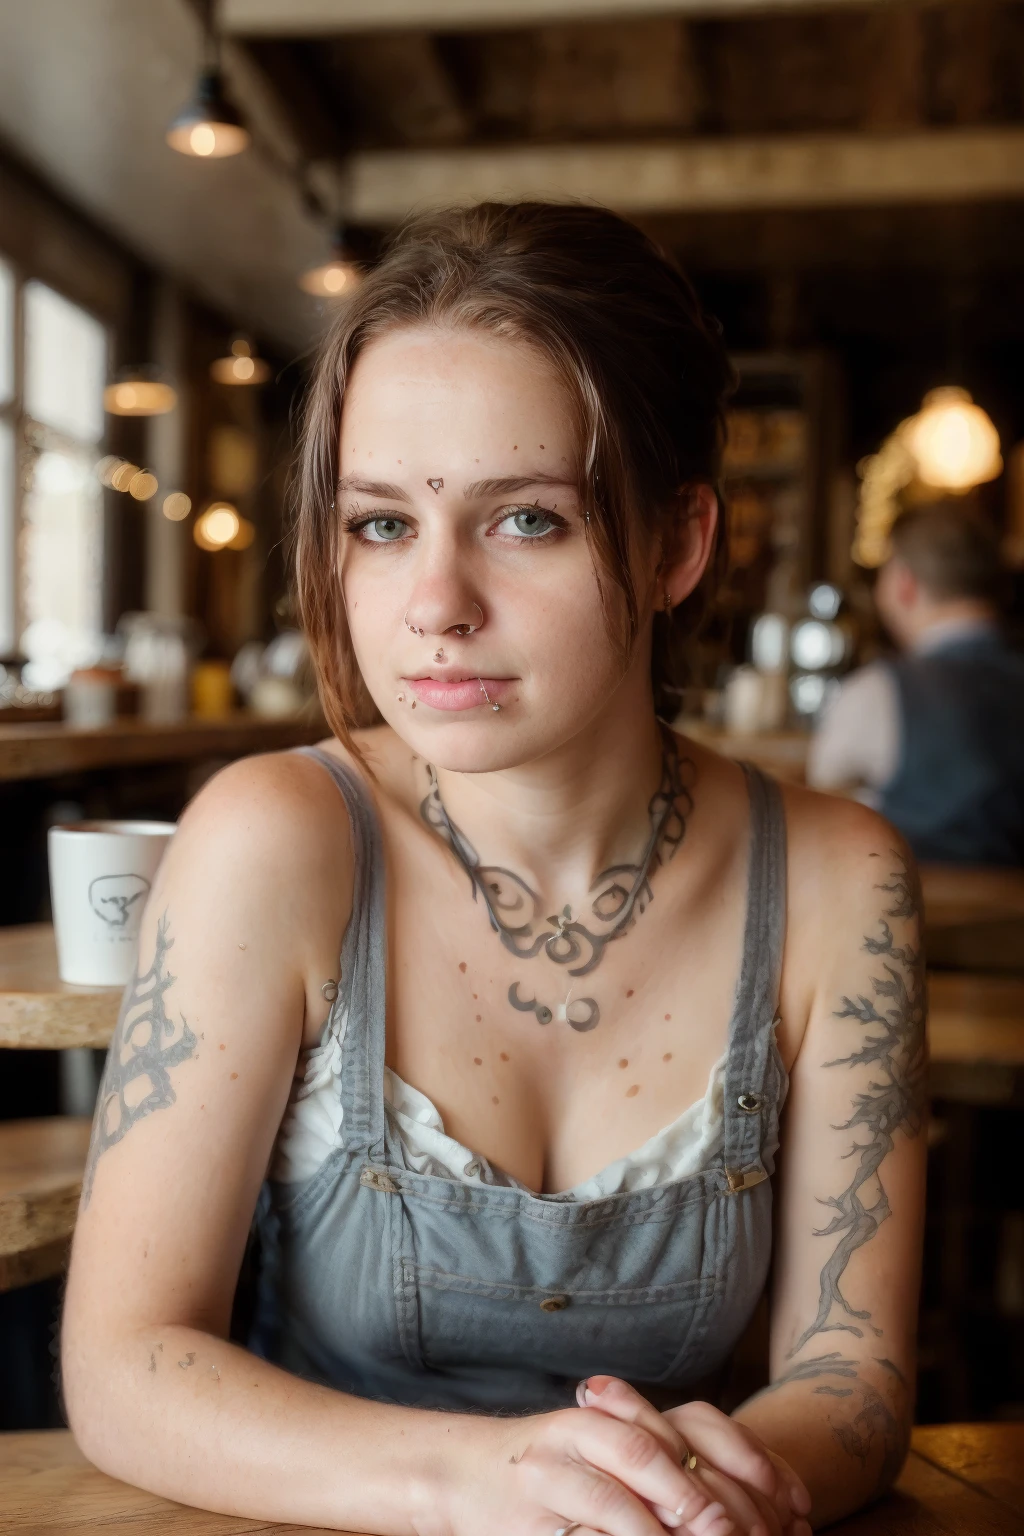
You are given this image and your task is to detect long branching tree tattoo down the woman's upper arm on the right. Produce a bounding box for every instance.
[789,851,926,1356]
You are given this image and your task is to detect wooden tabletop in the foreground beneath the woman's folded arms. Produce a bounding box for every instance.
[0,1424,1024,1536]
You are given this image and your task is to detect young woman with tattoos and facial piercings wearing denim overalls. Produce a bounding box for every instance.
[63,204,924,1536]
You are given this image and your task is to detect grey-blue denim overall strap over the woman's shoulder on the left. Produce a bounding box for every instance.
[296,746,387,1158]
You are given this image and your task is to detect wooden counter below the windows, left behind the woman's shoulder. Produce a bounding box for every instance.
[0,713,327,782]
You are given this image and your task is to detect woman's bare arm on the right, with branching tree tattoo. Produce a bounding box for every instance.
[737,809,926,1525]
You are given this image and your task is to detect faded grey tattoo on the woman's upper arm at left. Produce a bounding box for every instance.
[81,912,198,1210]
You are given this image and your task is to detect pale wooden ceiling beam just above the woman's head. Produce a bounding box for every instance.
[341,127,1024,226]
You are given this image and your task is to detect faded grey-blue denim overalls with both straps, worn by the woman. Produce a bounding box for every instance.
[250,748,788,1413]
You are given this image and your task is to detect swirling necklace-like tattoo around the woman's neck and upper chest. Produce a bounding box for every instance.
[419,730,695,1032]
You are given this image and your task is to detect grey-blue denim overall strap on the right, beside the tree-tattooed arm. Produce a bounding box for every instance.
[725,763,786,1192]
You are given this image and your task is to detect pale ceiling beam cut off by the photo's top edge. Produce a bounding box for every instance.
[216,0,896,37]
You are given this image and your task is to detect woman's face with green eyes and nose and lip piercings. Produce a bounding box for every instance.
[335,327,648,773]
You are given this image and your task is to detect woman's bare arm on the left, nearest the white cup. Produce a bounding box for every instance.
[63,759,448,1533]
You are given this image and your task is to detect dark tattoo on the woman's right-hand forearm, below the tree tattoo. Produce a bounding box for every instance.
[760,1350,910,1496]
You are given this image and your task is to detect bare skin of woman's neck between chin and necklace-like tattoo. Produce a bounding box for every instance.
[438,675,663,908]
